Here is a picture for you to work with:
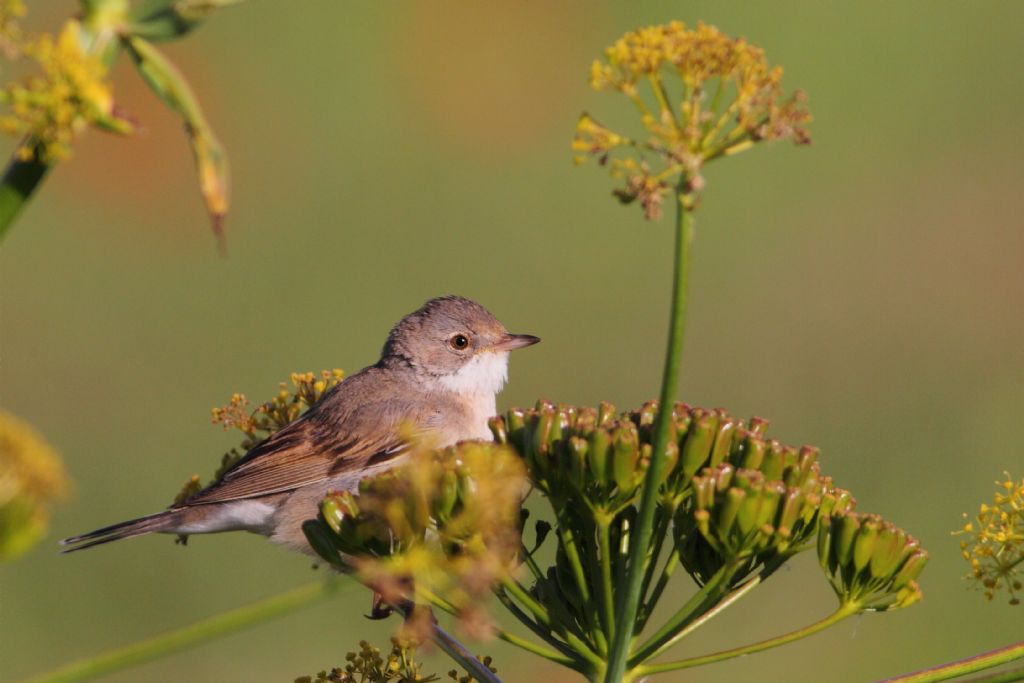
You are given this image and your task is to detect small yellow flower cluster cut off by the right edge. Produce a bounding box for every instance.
[957,473,1024,605]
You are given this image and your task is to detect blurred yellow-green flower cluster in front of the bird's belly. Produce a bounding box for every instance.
[305,441,526,640]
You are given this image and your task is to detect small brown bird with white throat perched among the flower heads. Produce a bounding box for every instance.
[60,296,541,553]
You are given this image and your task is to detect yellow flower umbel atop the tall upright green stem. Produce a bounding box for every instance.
[572,22,811,218]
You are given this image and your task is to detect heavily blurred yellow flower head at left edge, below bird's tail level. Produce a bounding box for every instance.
[0,412,68,560]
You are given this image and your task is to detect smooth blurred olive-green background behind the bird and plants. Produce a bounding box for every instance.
[0,0,1024,682]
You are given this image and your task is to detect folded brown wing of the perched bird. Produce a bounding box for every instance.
[186,395,406,506]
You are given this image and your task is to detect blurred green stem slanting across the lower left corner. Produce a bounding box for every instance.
[16,578,354,683]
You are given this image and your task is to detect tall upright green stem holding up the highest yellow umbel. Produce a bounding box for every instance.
[604,188,693,683]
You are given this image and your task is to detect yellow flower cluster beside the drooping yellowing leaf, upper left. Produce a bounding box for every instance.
[0,19,122,161]
